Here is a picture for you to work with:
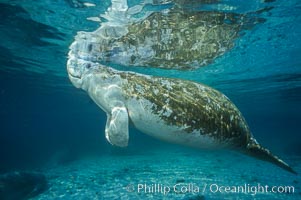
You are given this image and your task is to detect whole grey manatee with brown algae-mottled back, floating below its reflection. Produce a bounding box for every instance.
[67,34,295,173]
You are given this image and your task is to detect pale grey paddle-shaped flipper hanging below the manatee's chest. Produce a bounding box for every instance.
[105,107,129,147]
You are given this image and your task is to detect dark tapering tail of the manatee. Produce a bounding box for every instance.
[246,138,297,175]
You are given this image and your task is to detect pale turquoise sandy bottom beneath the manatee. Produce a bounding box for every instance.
[34,149,301,200]
